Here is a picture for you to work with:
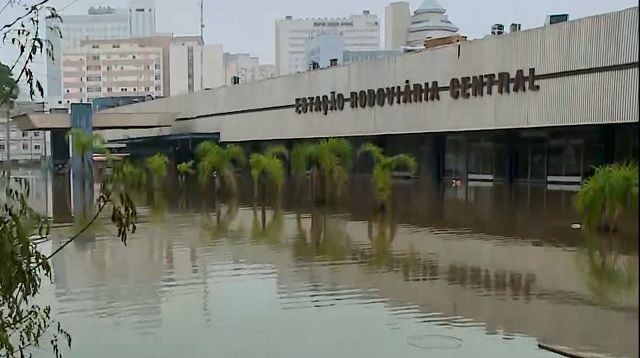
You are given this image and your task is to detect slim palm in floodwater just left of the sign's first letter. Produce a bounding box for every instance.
[249,145,288,205]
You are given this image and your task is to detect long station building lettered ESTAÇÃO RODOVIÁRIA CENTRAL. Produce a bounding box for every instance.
[92,7,639,185]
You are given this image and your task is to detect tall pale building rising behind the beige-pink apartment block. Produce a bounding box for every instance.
[45,0,155,107]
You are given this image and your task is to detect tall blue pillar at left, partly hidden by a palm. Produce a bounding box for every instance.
[71,103,94,222]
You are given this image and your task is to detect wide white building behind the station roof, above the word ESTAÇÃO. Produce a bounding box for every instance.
[276,10,380,75]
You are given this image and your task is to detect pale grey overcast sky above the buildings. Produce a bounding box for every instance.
[31,0,638,63]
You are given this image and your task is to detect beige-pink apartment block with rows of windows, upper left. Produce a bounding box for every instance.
[62,40,164,106]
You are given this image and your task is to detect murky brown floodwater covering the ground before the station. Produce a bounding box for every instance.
[18,172,638,357]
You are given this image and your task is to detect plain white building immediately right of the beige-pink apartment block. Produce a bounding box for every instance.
[169,36,225,96]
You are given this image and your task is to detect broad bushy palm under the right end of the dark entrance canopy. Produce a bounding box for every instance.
[196,141,246,194]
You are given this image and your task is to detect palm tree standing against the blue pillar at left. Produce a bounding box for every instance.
[67,128,108,220]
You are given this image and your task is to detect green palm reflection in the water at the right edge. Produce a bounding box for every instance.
[579,231,638,301]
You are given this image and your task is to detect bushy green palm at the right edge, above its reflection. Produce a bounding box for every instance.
[576,163,638,232]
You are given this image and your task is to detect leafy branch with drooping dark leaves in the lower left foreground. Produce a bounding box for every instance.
[0,169,137,358]
